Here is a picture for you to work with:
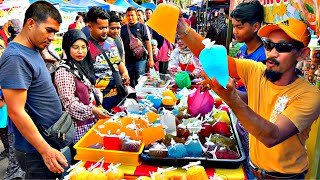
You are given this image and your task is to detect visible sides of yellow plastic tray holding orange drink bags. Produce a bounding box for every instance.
[74,120,144,166]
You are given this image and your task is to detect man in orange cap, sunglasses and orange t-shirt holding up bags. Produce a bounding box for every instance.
[177,18,320,179]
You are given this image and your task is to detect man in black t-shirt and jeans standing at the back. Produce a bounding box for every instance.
[121,7,154,87]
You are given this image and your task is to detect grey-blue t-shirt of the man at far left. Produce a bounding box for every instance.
[0,42,62,153]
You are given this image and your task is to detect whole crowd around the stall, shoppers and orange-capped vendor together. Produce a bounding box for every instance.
[0,1,320,179]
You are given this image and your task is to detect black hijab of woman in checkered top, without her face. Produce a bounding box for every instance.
[62,29,94,85]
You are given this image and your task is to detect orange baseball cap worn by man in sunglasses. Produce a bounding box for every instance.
[258,18,311,47]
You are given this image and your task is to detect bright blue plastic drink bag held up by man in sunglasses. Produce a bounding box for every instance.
[199,39,229,88]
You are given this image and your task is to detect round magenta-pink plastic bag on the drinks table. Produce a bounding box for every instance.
[188,87,214,117]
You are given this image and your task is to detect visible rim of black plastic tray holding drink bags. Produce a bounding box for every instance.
[141,113,246,169]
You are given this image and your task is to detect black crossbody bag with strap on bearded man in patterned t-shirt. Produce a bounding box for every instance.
[89,36,128,99]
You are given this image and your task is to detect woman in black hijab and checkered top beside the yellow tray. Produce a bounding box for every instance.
[55,29,108,162]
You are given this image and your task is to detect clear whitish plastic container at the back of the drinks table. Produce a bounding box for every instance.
[135,73,172,93]
